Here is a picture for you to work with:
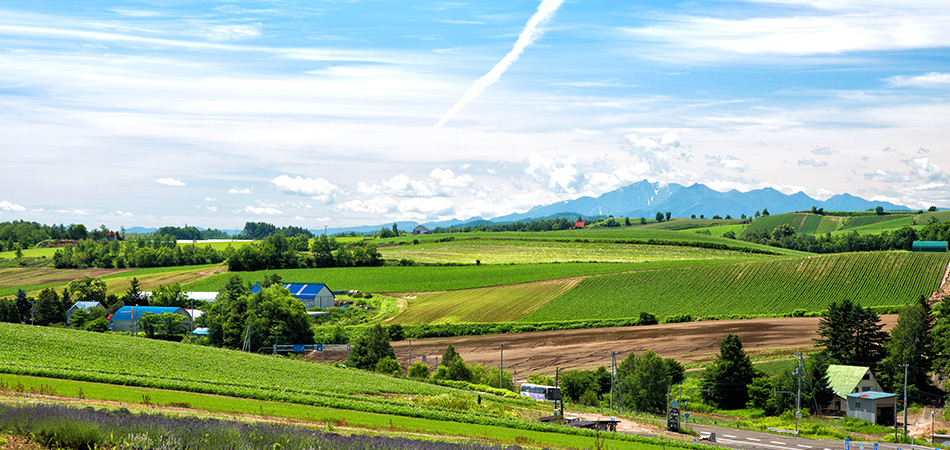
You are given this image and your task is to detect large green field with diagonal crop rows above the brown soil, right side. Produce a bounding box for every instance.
[522,252,950,322]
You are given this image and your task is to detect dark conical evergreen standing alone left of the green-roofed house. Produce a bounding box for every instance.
[703,334,758,409]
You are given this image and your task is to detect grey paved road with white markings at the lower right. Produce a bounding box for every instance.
[689,424,933,450]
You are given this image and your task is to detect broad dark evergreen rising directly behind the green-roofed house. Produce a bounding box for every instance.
[815,299,887,367]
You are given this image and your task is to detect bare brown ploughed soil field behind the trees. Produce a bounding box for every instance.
[390,315,897,380]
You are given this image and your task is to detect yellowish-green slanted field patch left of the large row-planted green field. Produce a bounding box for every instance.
[393,278,579,325]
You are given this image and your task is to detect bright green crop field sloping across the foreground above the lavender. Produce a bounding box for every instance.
[0,323,700,448]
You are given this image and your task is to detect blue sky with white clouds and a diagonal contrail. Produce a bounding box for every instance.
[0,0,950,229]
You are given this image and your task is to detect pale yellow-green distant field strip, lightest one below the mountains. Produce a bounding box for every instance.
[380,238,773,264]
